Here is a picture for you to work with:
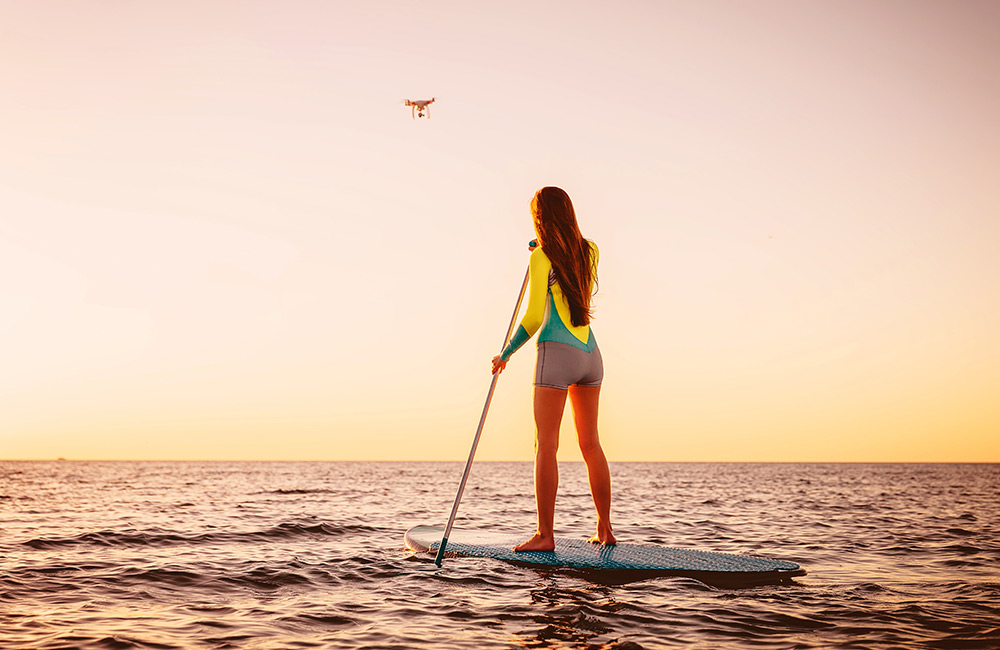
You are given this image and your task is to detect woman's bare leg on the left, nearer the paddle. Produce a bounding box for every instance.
[514,386,566,551]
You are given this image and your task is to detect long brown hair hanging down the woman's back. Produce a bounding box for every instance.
[531,187,597,327]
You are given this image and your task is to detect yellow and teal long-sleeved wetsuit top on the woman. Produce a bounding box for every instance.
[500,242,600,361]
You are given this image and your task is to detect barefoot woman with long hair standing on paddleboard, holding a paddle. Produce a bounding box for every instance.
[493,187,616,551]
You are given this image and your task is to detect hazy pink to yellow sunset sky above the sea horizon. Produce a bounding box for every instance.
[0,0,1000,462]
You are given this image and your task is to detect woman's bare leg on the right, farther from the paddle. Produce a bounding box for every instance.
[569,386,618,545]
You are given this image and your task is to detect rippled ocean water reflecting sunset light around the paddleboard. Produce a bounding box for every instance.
[0,461,1000,650]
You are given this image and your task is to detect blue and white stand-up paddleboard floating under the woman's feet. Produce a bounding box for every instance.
[404,526,806,583]
